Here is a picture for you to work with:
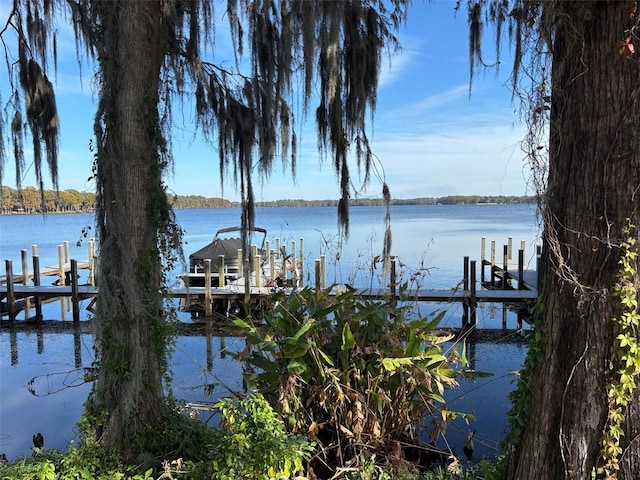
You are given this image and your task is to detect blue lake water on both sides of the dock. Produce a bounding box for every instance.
[0,205,539,459]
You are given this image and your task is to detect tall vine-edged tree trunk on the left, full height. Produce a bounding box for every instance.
[91,0,167,459]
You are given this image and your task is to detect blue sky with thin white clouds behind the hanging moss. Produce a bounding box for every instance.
[0,0,532,200]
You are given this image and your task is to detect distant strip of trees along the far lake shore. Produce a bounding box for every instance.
[0,187,536,215]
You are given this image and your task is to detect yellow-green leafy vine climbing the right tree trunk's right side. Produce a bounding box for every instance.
[597,223,640,480]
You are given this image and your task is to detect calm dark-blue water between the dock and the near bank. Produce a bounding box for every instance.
[0,321,526,460]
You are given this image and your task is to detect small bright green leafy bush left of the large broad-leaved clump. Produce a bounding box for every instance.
[189,395,314,480]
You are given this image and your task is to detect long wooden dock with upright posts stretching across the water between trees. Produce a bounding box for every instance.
[0,238,539,327]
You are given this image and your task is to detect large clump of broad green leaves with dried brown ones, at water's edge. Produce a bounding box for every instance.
[229,286,475,467]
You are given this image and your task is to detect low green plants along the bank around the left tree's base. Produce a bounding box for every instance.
[0,395,314,480]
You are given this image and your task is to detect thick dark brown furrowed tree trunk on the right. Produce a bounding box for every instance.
[510,2,640,480]
